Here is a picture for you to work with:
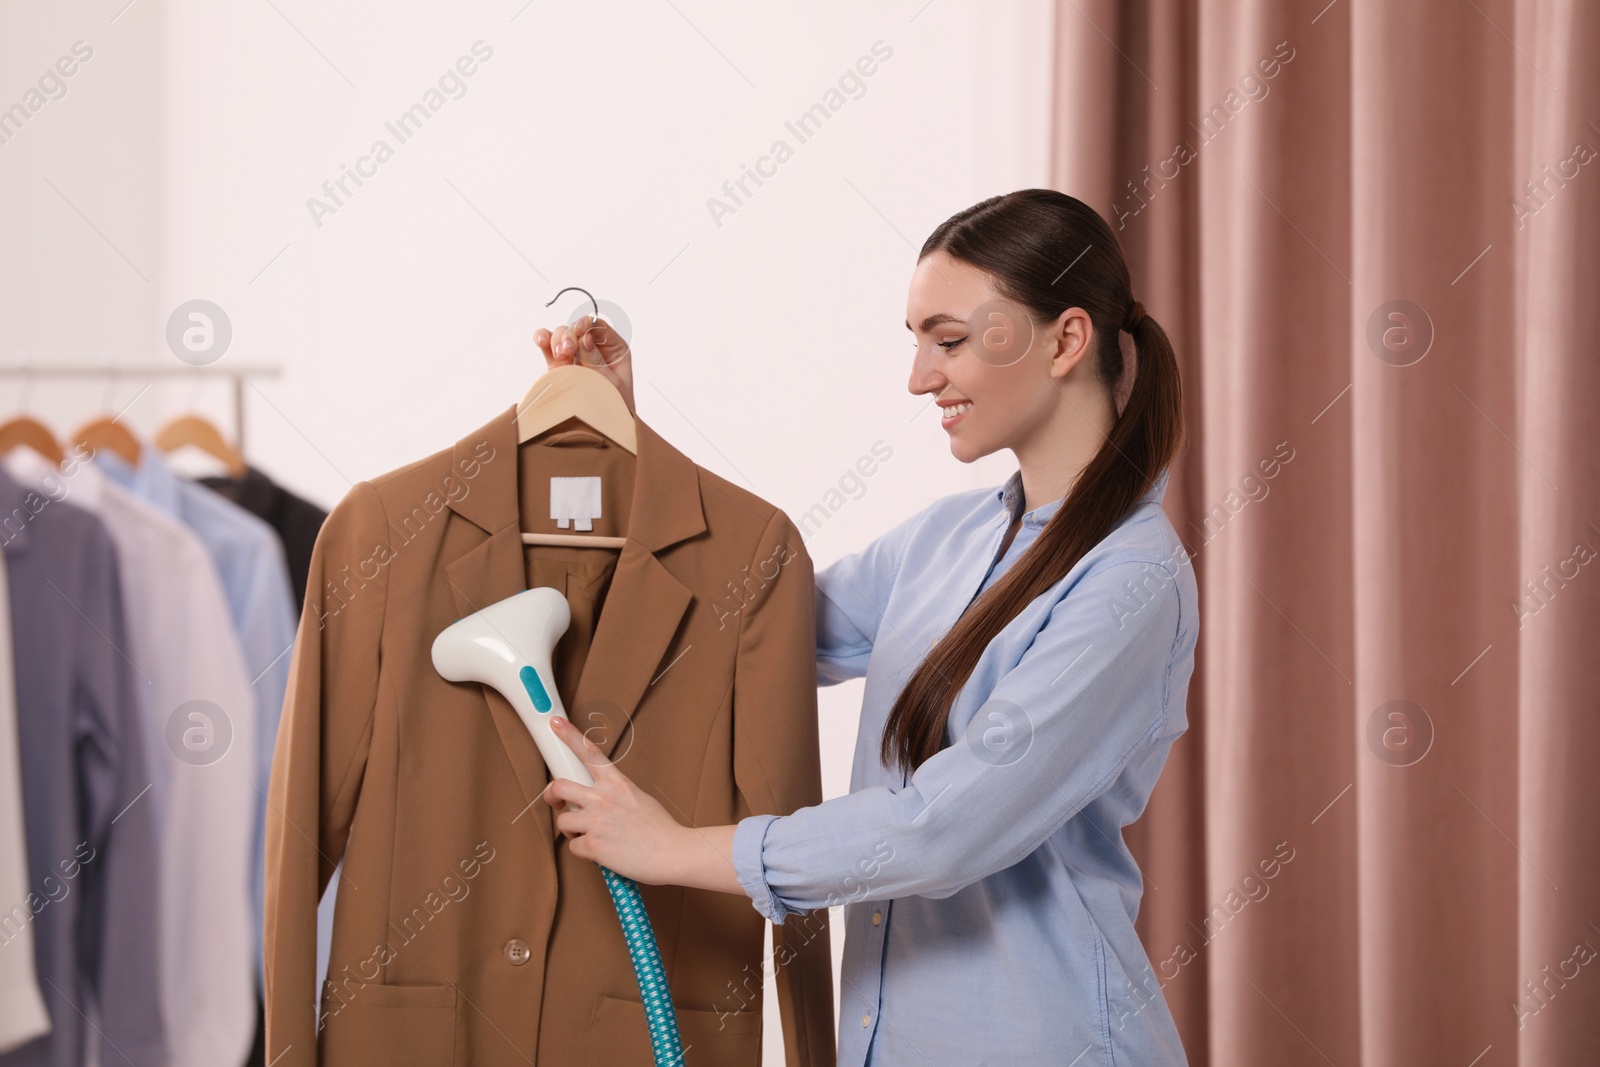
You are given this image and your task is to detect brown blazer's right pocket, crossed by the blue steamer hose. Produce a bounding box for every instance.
[589,993,762,1067]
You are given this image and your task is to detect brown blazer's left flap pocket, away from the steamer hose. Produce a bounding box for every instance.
[322,982,456,1067]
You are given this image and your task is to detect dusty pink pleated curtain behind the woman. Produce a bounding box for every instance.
[1053,0,1600,1067]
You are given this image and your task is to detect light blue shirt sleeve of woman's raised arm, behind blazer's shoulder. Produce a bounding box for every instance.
[816,506,931,685]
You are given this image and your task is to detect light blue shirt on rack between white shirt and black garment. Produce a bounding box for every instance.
[94,445,299,976]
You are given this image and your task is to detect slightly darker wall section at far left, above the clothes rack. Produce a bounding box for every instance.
[0,3,162,361]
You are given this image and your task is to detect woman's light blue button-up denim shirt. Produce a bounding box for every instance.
[733,470,1200,1067]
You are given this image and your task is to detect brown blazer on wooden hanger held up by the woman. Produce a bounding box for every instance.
[266,408,834,1067]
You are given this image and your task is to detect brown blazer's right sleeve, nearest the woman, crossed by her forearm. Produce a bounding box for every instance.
[733,510,835,1067]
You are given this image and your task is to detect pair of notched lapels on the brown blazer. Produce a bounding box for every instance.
[445,405,706,845]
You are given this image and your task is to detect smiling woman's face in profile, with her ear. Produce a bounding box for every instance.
[906,251,1093,462]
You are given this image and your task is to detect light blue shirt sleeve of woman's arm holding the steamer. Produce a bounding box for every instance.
[733,558,1192,921]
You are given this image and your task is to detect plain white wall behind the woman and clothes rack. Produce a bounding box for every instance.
[0,0,1051,1062]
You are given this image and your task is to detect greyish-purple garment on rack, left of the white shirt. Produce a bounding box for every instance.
[0,467,166,1067]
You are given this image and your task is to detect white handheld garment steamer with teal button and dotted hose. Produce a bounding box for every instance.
[434,585,683,1067]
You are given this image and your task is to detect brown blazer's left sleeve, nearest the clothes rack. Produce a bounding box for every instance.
[264,482,392,1067]
